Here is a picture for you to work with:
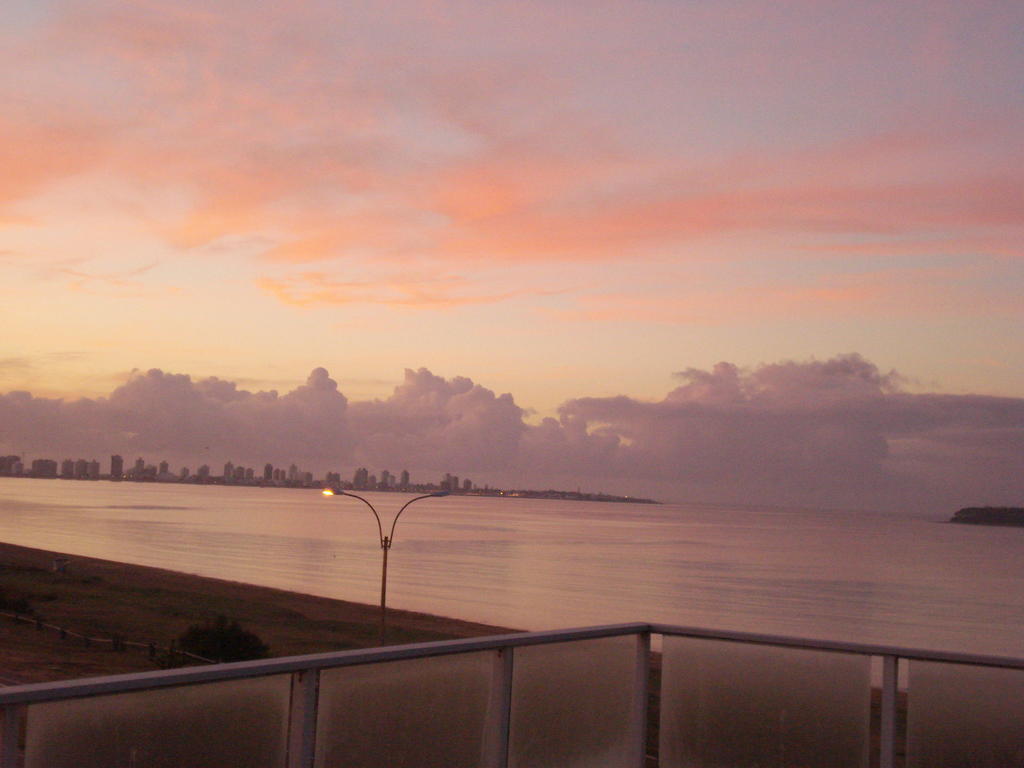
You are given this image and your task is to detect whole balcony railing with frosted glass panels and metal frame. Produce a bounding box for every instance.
[0,624,1024,768]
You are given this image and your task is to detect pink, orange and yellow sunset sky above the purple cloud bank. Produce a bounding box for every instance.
[0,0,1024,512]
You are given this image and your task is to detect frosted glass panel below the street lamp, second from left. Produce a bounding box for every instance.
[315,653,497,768]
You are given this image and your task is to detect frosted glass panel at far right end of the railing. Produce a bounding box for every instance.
[907,662,1024,768]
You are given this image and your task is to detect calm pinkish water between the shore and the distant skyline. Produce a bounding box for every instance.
[0,478,1024,655]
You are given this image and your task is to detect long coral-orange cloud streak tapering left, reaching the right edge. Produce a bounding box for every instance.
[434,144,1024,259]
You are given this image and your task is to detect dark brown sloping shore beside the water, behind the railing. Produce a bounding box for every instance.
[0,543,511,685]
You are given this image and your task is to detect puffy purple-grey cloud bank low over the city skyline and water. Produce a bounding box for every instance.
[0,355,1024,510]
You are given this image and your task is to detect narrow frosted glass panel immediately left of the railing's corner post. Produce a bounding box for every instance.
[509,635,637,768]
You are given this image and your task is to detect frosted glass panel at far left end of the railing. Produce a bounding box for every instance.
[25,675,291,768]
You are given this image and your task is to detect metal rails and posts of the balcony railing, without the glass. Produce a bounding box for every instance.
[0,623,1024,768]
